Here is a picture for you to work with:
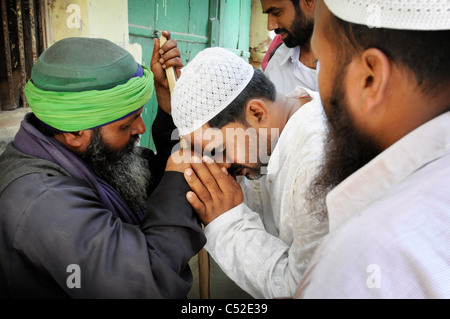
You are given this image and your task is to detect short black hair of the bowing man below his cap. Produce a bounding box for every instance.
[208,68,277,129]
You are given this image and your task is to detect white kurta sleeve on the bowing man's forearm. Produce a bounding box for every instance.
[205,204,300,298]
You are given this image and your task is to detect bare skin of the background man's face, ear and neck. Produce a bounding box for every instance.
[261,0,317,69]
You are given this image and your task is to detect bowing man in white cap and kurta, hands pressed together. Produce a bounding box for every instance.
[172,48,328,298]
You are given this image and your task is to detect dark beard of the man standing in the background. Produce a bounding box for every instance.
[275,8,314,48]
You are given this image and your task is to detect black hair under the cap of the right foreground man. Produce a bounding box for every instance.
[327,14,450,93]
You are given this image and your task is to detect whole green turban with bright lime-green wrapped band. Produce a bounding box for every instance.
[25,38,154,132]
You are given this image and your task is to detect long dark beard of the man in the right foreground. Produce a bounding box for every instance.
[307,68,382,221]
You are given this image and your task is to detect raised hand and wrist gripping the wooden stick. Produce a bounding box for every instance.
[150,31,183,114]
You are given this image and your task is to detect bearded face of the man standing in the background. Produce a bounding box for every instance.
[261,0,314,48]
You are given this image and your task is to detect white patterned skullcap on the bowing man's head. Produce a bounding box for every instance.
[172,47,254,135]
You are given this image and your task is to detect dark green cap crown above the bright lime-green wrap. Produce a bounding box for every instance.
[31,37,138,92]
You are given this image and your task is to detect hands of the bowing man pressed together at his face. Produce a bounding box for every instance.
[184,156,244,225]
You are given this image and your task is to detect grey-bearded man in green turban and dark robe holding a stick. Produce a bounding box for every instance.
[0,33,205,298]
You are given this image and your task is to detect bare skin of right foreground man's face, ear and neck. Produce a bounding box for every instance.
[311,1,449,150]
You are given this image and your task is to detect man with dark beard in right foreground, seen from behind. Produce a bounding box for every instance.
[296,0,450,299]
